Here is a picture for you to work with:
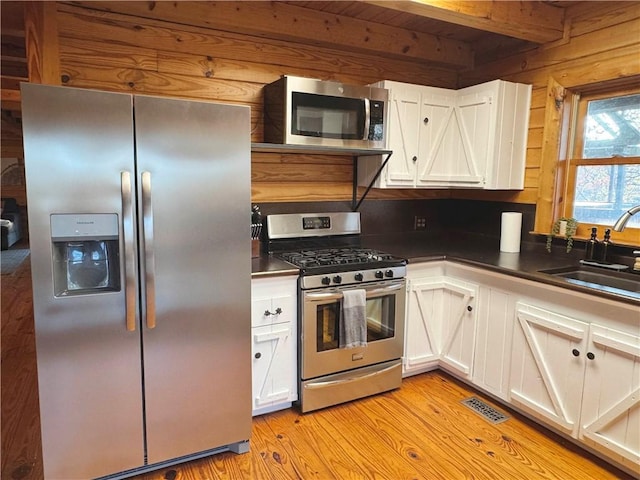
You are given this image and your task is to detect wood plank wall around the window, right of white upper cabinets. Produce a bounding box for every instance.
[453,2,640,221]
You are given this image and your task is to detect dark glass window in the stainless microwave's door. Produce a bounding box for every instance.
[291,92,366,140]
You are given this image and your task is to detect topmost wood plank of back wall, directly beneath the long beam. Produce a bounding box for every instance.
[58,5,457,88]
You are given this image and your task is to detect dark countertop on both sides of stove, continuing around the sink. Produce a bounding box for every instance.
[252,232,640,308]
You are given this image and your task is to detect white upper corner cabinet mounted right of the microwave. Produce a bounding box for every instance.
[358,80,531,190]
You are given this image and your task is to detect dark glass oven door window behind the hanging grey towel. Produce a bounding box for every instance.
[316,295,396,352]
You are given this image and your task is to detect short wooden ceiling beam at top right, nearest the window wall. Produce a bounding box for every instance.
[365,0,564,44]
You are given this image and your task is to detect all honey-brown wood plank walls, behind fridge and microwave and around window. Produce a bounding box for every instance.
[25,2,640,204]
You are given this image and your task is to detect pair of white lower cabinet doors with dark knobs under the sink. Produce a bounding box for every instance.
[511,303,640,473]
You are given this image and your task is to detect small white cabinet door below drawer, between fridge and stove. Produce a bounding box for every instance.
[251,323,296,413]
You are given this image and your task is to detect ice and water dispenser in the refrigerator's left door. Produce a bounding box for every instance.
[51,213,120,297]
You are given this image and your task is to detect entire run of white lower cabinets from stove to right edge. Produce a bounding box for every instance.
[403,261,640,476]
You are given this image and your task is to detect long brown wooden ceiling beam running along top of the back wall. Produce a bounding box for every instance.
[73,1,473,69]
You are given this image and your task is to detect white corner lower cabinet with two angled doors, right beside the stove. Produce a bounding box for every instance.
[403,262,477,378]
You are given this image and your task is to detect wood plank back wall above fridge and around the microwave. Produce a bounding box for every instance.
[52,0,457,202]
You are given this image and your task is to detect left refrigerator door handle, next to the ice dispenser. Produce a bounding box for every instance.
[120,171,136,332]
